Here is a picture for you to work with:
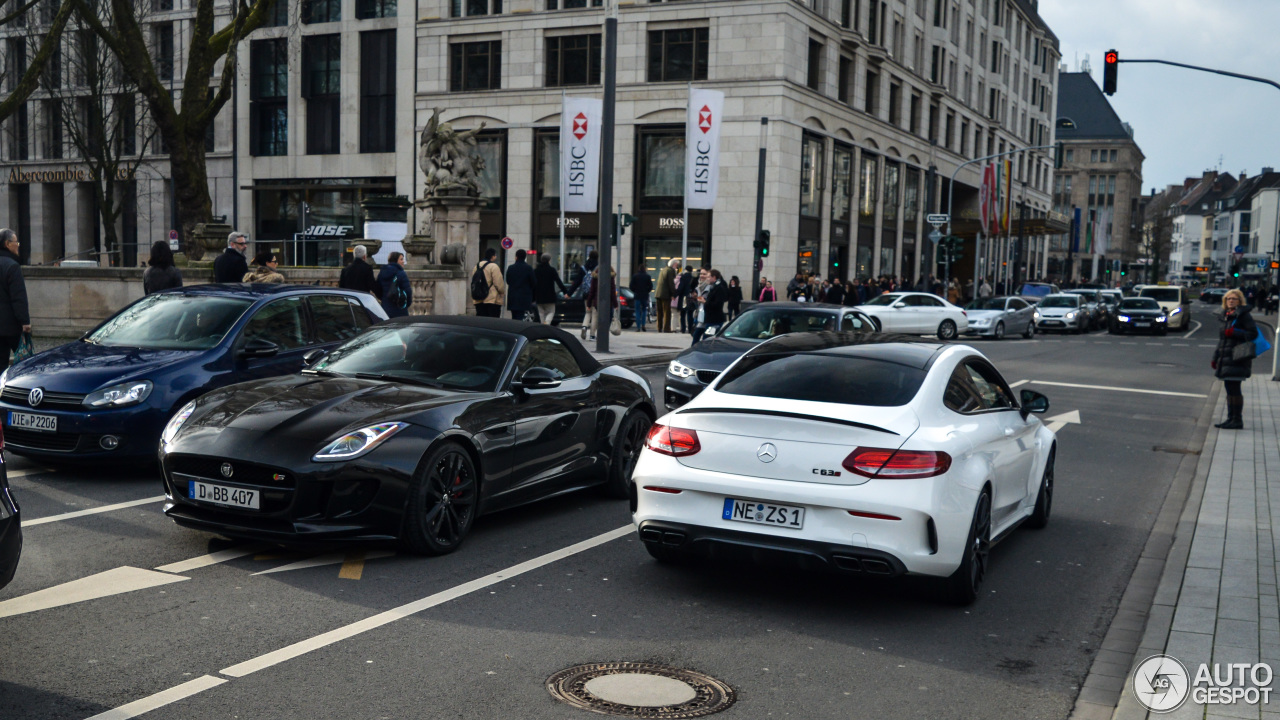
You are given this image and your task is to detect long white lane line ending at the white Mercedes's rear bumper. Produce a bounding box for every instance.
[229,524,635,678]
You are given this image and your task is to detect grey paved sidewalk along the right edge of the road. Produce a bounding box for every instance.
[1071,371,1280,720]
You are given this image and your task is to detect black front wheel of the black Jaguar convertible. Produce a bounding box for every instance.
[401,443,480,555]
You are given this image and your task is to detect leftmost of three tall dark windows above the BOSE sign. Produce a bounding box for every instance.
[248,37,289,156]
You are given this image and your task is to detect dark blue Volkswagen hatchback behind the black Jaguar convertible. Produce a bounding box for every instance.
[0,284,387,464]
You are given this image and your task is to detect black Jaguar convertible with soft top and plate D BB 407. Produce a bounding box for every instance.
[160,316,655,555]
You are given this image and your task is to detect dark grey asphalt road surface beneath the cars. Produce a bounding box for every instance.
[0,304,1239,720]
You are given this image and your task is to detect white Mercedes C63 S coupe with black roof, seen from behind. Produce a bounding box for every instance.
[631,333,1057,603]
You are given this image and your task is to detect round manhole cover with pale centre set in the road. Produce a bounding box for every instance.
[547,662,735,717]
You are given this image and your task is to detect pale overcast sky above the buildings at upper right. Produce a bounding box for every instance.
[1039,0,1280,192]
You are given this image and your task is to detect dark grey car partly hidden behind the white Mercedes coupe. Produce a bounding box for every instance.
[663,302,876,410]
